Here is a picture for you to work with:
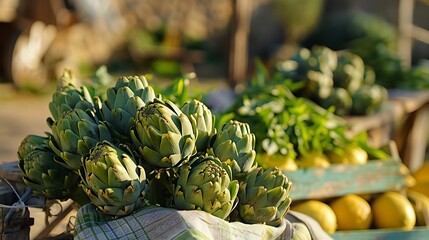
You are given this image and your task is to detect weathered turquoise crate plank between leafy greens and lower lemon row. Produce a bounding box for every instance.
[284,159,406,201]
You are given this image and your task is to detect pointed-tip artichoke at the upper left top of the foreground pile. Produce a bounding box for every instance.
[48,70,94,122]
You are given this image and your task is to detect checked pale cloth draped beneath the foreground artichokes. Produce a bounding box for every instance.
[74,204,293,240]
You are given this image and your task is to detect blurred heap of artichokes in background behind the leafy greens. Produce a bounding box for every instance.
[273,46,388,116]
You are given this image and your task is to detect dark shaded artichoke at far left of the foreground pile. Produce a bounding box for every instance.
[18,135,84,200]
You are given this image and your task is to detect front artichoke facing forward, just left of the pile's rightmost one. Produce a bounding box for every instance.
[174,155,239,219]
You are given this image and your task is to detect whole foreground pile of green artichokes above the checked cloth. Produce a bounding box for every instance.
[18,71,291,226]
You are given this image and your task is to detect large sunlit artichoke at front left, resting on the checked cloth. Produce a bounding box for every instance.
[79,141,147,217]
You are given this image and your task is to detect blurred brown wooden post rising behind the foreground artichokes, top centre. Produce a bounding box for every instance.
[228,0,251,87]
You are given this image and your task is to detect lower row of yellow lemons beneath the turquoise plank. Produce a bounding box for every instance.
[291,163,429,233]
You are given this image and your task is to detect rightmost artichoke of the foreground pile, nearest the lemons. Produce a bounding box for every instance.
[237,167,292,226]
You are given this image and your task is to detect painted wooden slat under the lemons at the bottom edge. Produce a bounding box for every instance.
[331,227,429,240]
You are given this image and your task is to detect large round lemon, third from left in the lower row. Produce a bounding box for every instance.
[371,192,416,230]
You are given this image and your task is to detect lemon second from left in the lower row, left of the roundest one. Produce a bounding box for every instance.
[330,194,372,230]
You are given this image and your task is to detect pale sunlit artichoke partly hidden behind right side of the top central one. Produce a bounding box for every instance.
[181,99,215,152]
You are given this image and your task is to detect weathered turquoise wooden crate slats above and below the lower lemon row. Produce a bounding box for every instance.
[285,142,429,240]
